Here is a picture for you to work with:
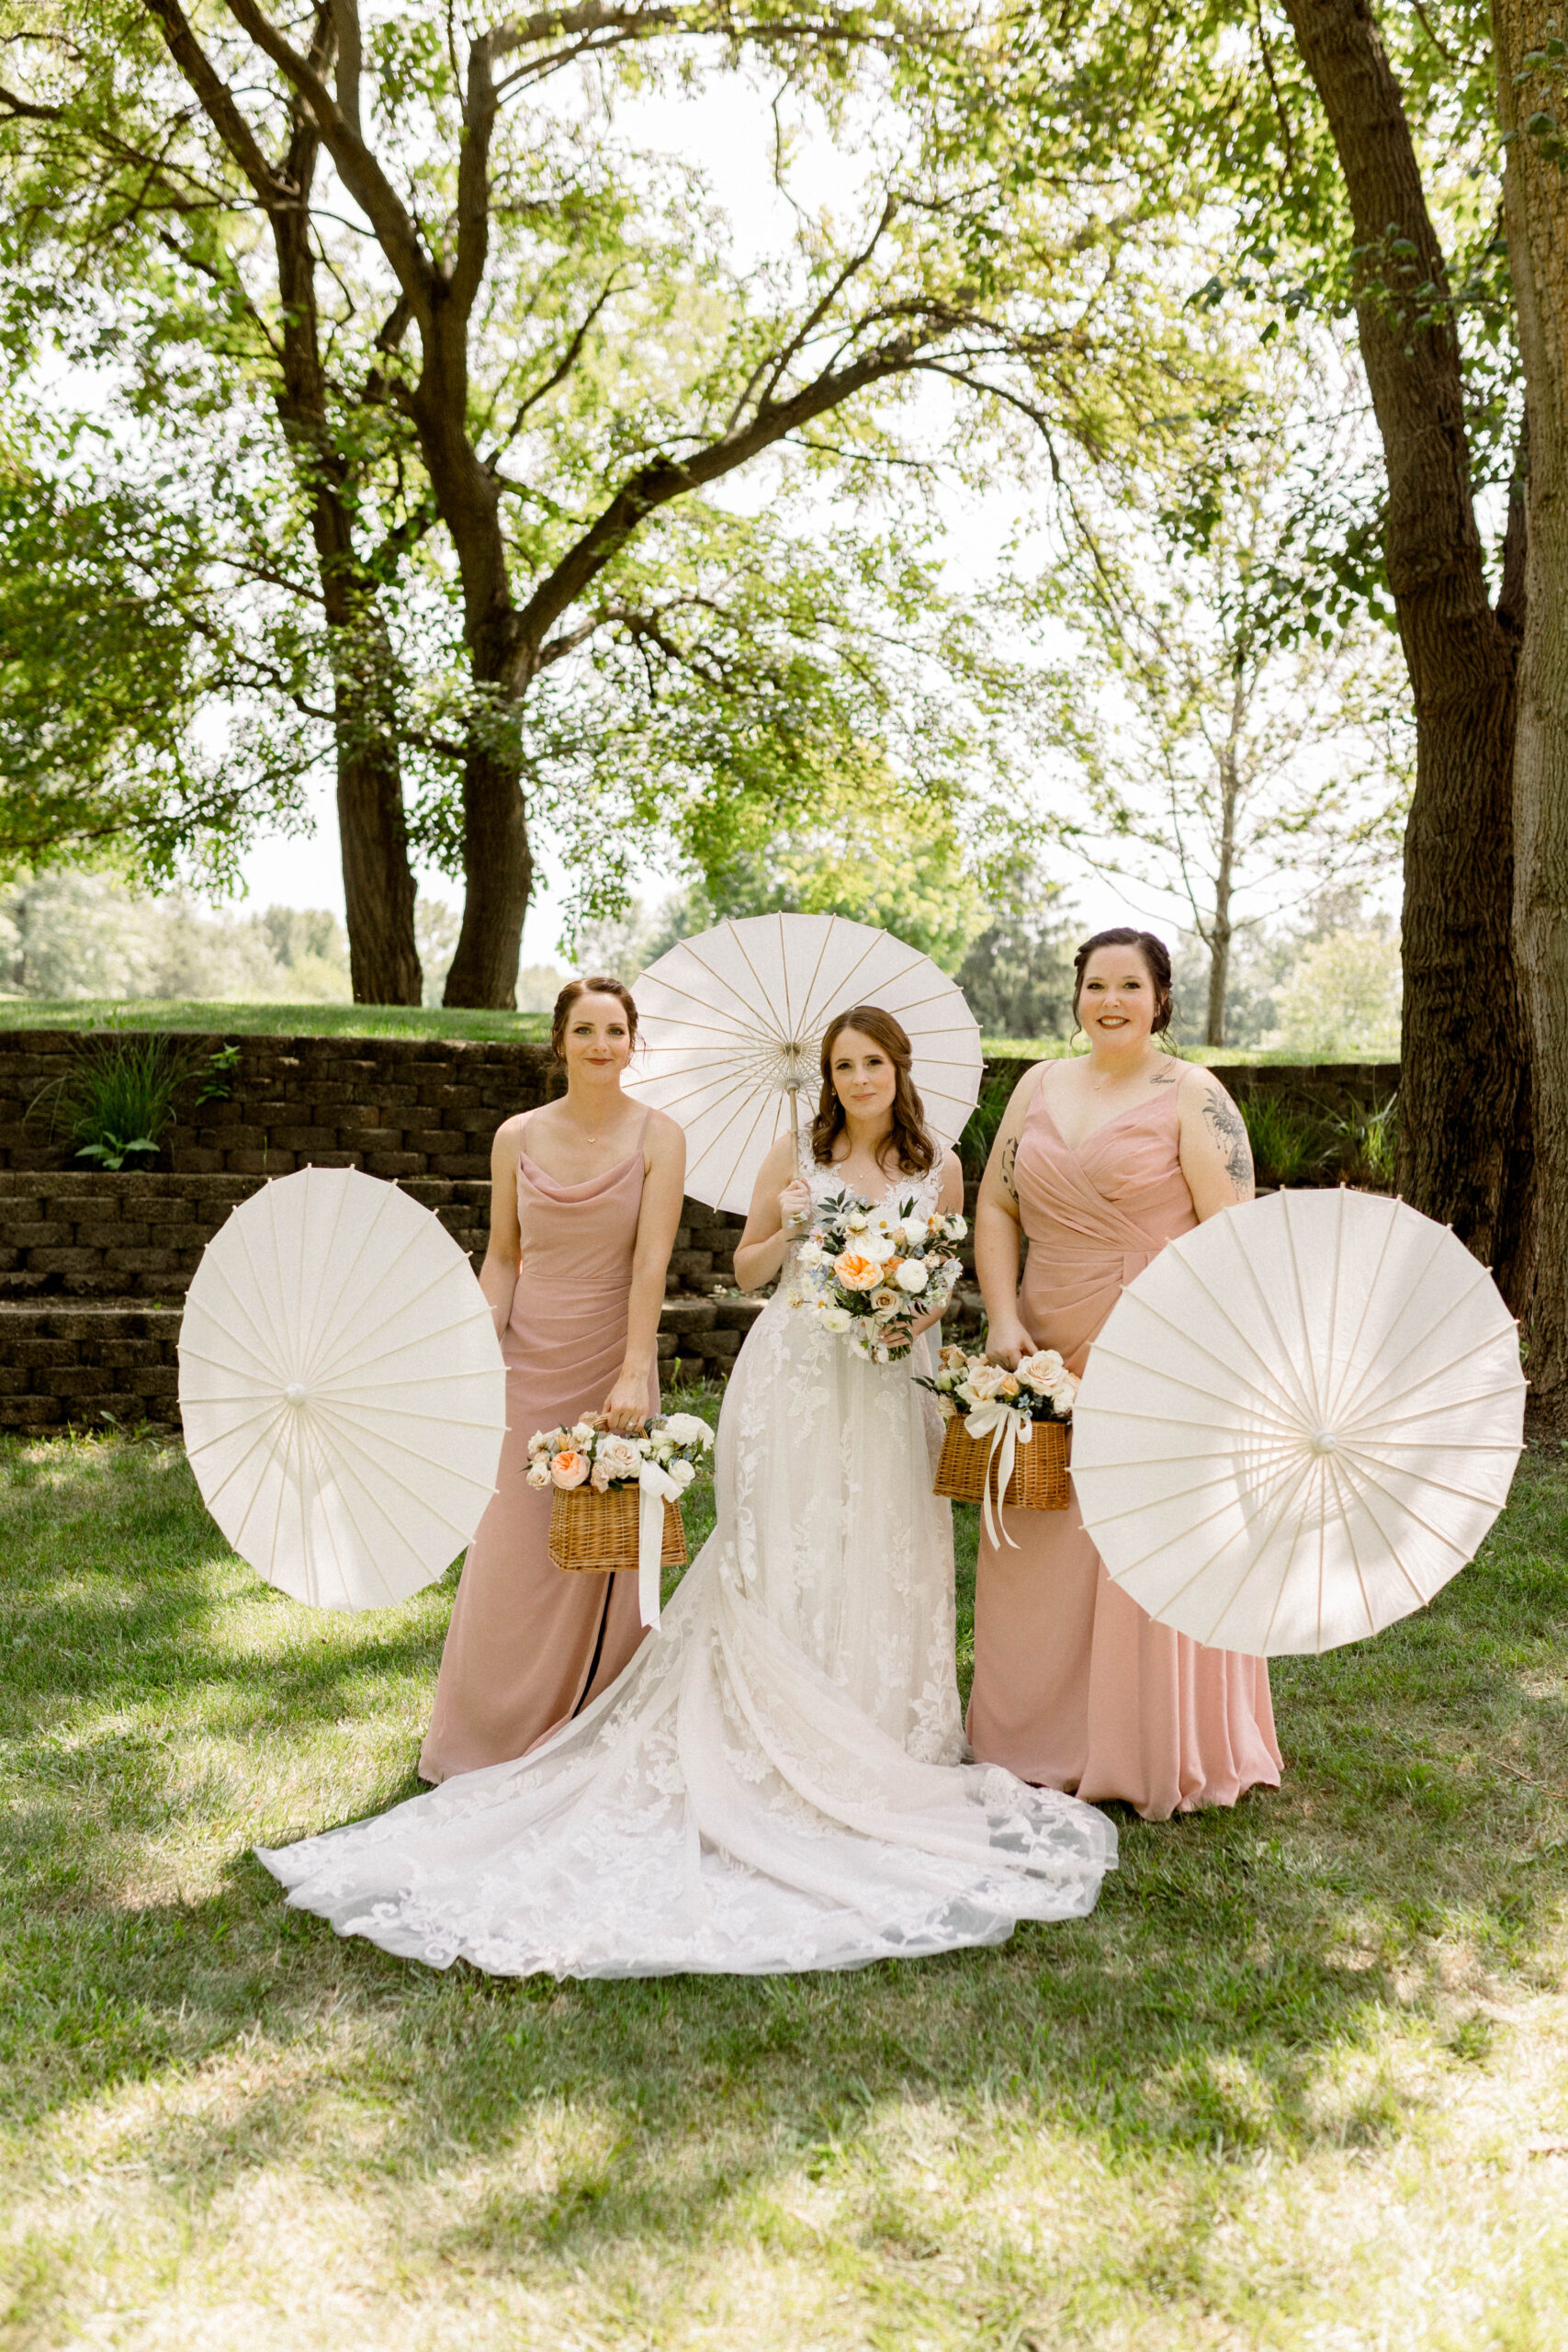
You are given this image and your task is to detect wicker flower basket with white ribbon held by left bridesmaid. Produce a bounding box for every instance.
[526,1414,712,1628]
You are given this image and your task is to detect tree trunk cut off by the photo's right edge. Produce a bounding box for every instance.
[1493,0,1568,1432]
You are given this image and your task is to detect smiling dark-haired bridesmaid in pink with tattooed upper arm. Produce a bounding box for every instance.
[968,927,1279,1820]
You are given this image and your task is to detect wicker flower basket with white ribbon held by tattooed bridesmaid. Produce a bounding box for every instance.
[921,1348,1079,1550]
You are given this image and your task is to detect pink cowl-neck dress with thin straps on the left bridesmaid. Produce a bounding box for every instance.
[419,1113,659,1781]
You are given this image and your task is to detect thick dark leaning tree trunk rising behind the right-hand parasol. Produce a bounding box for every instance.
[1286,0,1530,1303]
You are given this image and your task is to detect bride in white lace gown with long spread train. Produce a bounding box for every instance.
[261,1004,1117,1975]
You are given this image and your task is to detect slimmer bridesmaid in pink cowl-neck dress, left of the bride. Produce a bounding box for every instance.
[419,981,686,1781]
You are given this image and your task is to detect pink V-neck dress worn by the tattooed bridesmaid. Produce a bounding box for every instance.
[968,1084,1279,1820]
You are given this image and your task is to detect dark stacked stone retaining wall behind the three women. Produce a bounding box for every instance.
[0,1030,1399,1430]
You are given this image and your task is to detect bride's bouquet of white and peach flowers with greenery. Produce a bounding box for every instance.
[790,1193,968,1364]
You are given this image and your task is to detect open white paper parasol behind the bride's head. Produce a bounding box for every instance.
[626,915,983,1214]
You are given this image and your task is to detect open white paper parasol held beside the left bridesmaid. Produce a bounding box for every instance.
[179,1169,505,1609]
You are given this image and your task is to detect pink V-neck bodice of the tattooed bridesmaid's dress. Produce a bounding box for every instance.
[1013,1082,1197,1371]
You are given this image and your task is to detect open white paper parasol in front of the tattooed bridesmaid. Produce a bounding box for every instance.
[1072,1190,1526,1658]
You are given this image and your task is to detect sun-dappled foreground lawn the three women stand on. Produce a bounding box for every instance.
[0,1411,1568,2352]
